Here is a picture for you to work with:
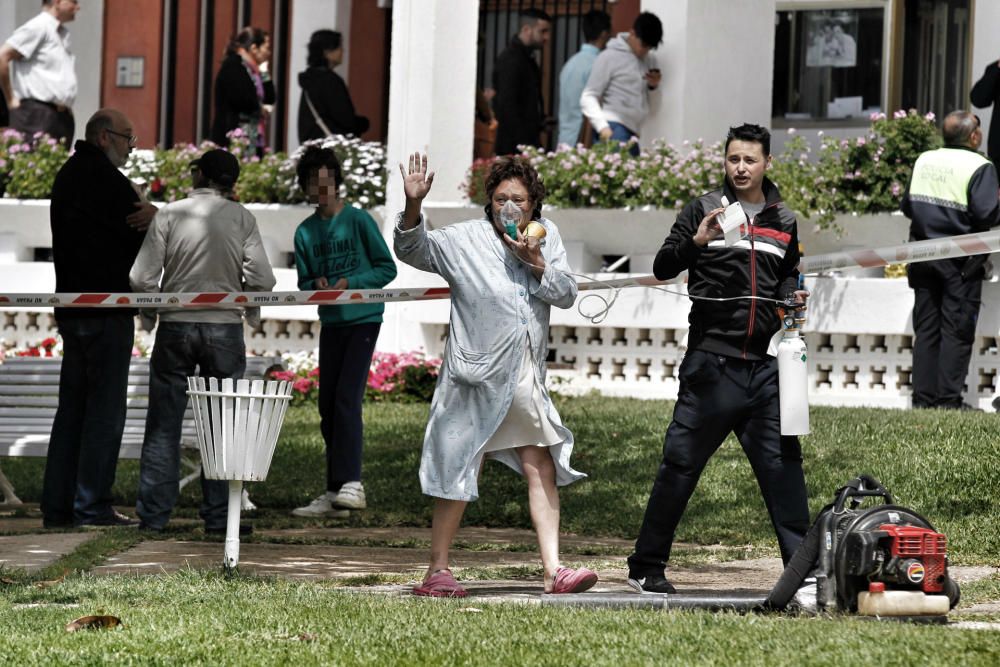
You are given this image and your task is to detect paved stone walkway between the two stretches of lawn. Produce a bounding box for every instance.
[0,512,1000,614]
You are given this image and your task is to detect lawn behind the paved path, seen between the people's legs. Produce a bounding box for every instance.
[3,397,1000,565]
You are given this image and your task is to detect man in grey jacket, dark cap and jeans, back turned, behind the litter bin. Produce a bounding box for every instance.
[129,149,275,534]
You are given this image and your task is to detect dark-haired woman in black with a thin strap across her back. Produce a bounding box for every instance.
[299,30,368,143]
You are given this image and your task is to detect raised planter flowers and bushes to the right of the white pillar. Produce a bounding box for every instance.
[463,110,941,232]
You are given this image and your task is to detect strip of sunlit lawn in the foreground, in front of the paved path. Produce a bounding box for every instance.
[0,571,1000,667]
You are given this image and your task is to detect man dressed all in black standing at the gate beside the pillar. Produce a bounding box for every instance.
[493,9,552,155]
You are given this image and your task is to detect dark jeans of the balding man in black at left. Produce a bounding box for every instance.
[41,314,135,526]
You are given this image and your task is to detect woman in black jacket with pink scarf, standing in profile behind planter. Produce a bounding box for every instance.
[211,27,275,155]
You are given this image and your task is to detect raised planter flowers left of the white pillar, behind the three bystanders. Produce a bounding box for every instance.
[0,129,386,208]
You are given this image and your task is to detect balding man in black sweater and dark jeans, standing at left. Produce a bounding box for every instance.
[41,109,156,528]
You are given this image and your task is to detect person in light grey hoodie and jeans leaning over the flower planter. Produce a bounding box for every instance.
[580,12,663,155]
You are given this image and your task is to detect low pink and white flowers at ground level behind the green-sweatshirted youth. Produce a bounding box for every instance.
[268,352,441,404]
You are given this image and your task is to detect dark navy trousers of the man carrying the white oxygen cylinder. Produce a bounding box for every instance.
[628,350,809,577]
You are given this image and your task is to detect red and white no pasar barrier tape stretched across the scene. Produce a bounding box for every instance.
[0,230,1000,309]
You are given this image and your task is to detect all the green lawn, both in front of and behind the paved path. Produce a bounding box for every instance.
[0,397,1000,667]
